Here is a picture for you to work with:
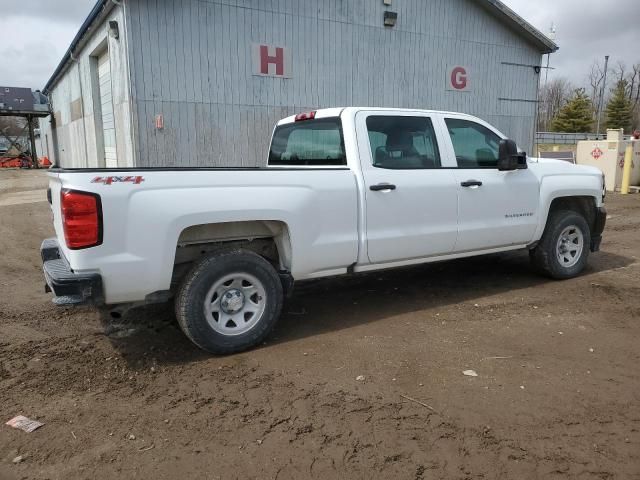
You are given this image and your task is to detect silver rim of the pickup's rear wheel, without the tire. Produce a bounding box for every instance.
[204,273,267,336]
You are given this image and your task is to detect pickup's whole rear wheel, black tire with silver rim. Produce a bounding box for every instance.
[175,248,283,355]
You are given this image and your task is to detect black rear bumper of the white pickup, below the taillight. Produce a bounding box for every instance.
[40,238,104,305]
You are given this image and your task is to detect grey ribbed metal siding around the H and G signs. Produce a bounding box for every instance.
[127,0,541,166]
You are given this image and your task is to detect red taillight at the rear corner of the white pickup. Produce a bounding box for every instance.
[60,190,102,250]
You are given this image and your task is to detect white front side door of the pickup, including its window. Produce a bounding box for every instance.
[444,116,539,253]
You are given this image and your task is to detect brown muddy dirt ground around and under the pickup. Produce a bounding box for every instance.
[0,171,640,480]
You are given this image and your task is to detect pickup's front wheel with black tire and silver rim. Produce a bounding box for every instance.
[530,210,591,280]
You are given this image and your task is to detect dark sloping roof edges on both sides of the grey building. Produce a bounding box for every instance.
[42,0,558,94]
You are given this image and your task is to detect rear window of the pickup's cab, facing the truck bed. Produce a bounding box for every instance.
[269,117,347,167]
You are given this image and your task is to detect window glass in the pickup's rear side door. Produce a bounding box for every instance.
[367,115,442,170]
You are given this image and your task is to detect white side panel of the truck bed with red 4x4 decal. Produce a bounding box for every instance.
[49,168,359,303]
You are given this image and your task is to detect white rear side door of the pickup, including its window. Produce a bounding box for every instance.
[356,111,458,264]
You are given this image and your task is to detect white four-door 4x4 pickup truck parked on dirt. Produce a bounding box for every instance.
[41,108,606,354]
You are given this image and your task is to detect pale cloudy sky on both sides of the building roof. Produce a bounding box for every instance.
[0,0,640,90]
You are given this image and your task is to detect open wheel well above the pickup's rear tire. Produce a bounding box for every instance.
[171,220,291,288]
